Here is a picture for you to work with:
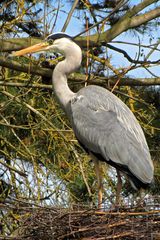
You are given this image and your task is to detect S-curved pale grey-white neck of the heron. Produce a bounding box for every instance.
[52,42,82,112]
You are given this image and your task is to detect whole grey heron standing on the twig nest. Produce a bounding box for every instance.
[12,32,154,206]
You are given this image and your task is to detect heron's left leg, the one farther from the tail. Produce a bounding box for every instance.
[93,157,103,209]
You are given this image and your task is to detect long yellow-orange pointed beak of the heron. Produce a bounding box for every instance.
[12,42,49,56]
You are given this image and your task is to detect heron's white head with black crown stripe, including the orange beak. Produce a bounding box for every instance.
[12,33,80,56]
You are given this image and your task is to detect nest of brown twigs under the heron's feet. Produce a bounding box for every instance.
[10,202,160,240]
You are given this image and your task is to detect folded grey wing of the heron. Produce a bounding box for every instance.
[71,86,153,183]
